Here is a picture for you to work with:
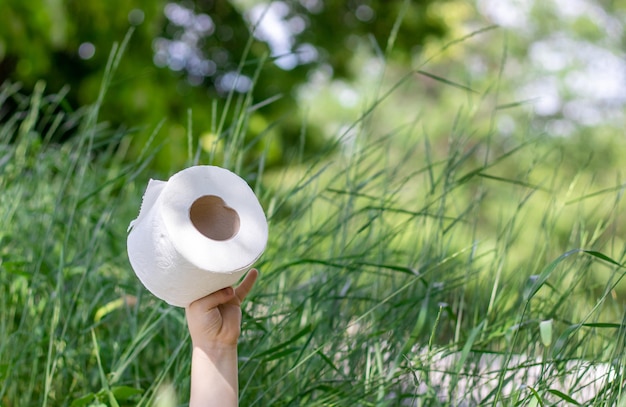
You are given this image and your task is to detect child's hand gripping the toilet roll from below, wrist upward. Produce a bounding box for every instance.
[185,269,259,348]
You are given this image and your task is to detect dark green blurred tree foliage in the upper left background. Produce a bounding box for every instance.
[0,0,447,171]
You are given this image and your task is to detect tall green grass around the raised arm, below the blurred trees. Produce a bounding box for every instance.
[0,35,626,407]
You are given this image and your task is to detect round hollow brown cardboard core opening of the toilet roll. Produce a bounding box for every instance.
[189,195,239,240]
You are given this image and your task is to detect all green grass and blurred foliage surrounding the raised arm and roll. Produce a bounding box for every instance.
[0,0,626,406]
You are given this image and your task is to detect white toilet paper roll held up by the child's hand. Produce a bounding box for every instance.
[127,165,268,307]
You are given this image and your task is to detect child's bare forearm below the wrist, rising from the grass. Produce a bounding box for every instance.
[189,345,239,407]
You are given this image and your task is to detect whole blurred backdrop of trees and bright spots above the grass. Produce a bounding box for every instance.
[0,0,626,172]
